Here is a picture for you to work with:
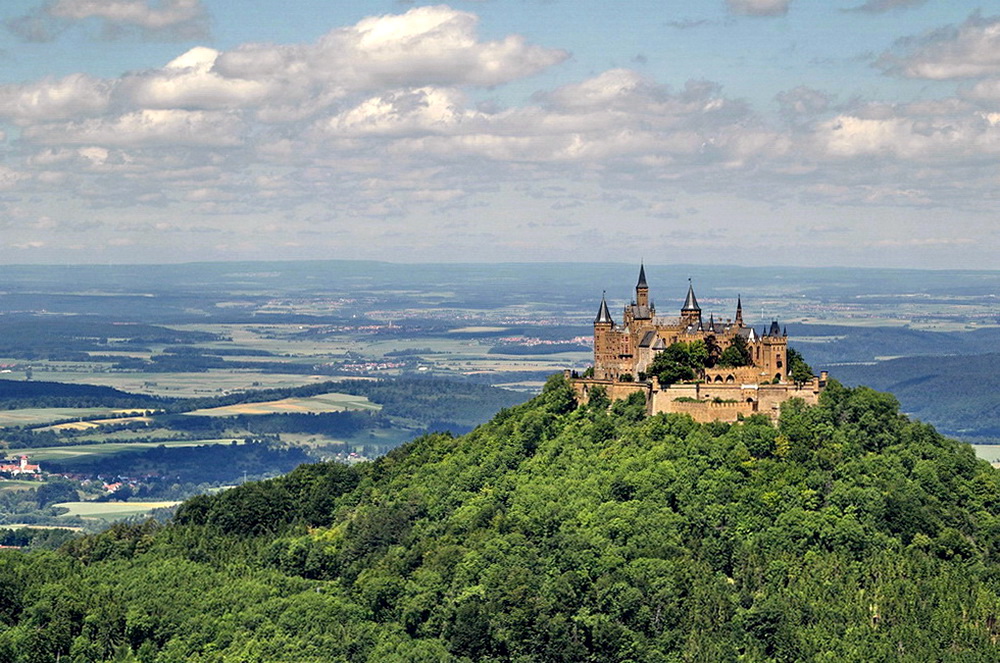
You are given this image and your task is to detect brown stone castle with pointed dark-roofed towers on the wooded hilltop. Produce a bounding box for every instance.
[571,265,827,422]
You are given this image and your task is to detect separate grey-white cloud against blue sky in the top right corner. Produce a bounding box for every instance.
[876,13,1000,80]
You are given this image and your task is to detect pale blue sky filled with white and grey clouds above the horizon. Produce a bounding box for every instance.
[0,0,1000,269]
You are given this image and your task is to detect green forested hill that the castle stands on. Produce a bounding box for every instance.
[0,378,1000,663]
